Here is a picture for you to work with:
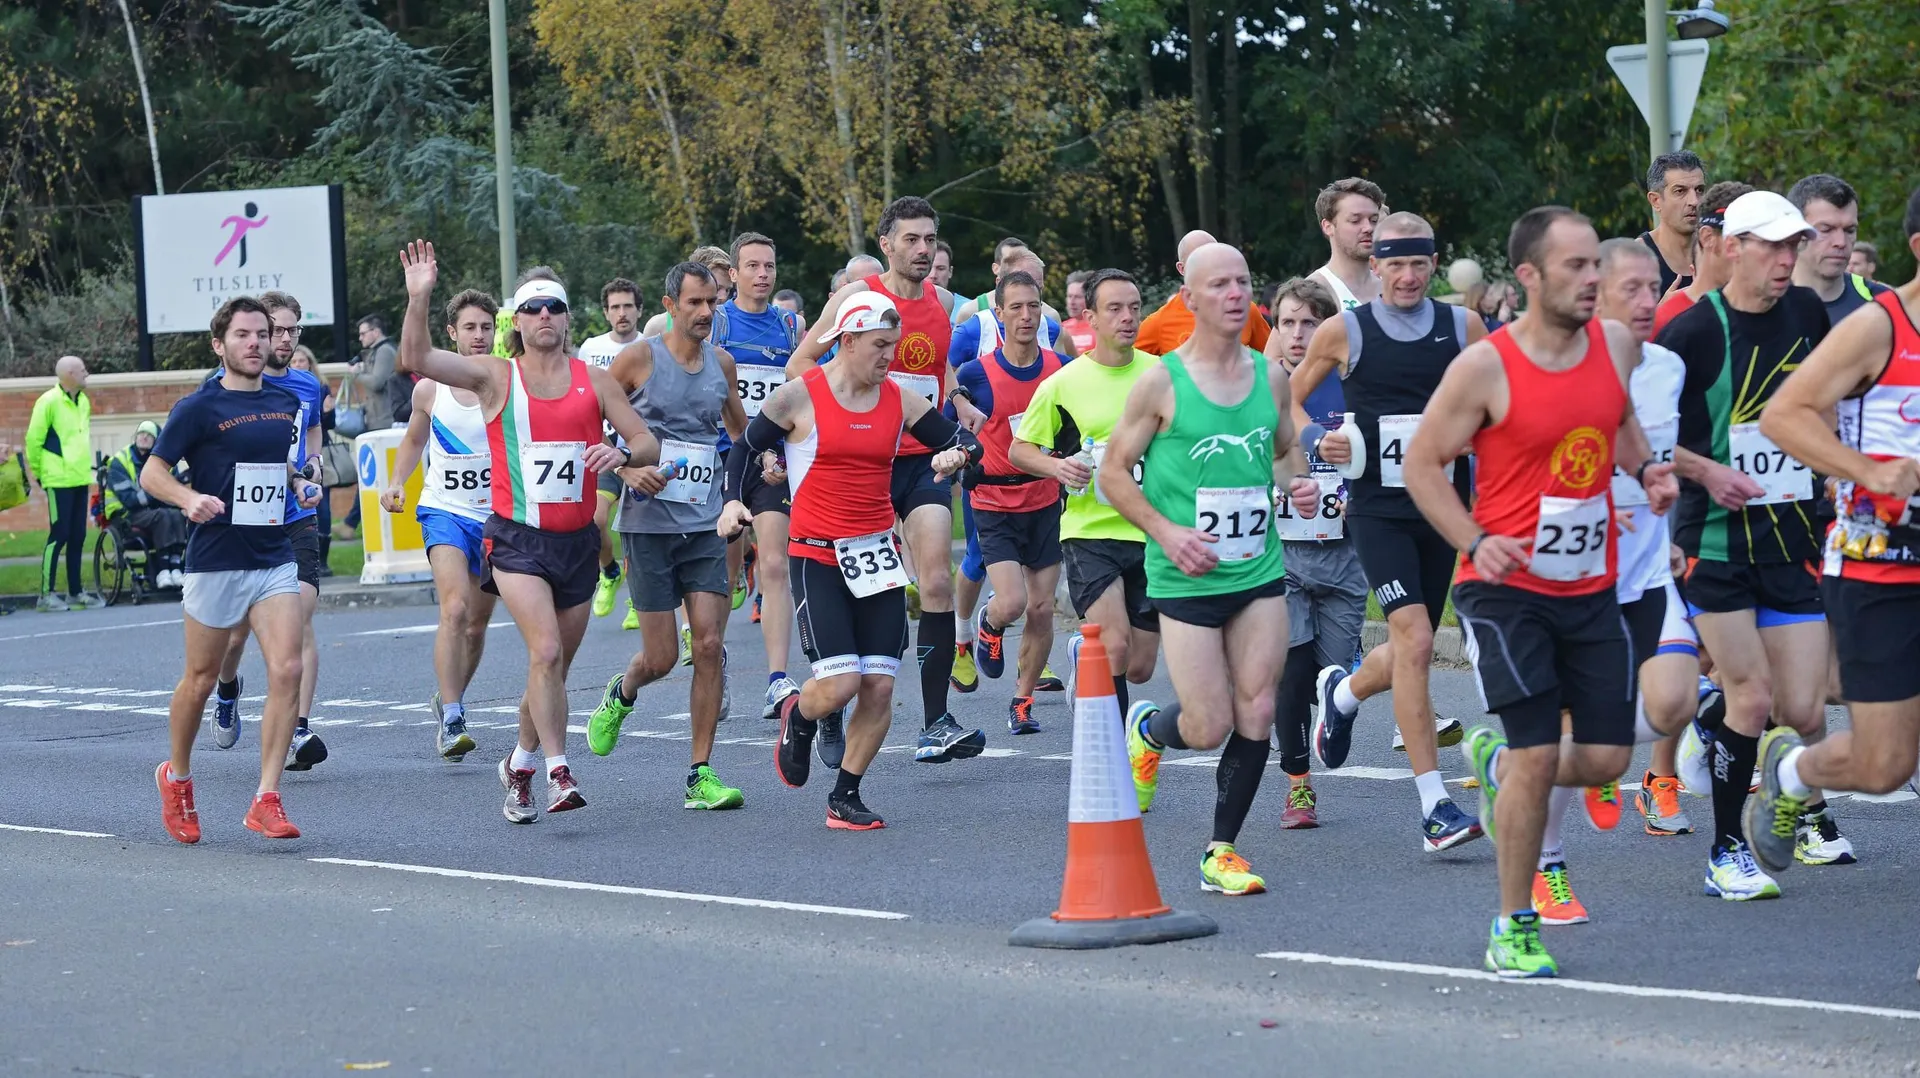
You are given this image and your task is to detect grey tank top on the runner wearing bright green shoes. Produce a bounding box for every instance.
[614,336,733,534]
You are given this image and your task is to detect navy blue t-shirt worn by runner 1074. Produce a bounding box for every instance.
[154,379,301,573]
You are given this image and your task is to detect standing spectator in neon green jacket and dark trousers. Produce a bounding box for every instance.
[27,355,106,611]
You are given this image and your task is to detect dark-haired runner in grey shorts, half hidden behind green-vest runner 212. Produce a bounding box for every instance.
[1267,274,1373,830]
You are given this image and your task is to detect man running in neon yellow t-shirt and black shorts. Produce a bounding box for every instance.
[1006,269,1160,713]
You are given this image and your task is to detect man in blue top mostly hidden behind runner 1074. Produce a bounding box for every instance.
[209,292,326,771]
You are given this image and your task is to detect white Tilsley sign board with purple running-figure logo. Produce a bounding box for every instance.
[140,186,336,332]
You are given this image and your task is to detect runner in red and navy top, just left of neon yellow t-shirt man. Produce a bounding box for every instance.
[954,269,1073,734]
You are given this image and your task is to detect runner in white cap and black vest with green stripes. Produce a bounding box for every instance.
[1659,190,1853,901]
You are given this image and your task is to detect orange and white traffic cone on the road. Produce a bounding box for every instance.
[1010,623,1219,949]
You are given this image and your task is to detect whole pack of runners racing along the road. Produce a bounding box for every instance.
[142,174,1920,976]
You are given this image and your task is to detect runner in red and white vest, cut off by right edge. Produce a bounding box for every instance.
[1745,188,1920,870]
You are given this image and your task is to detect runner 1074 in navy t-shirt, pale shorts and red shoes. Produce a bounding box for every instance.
[140,296,323,844]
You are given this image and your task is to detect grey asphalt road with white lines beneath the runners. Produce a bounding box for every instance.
[0,605,1920,1076]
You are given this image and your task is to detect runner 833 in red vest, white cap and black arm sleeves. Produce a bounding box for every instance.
[718,290,981,830]
